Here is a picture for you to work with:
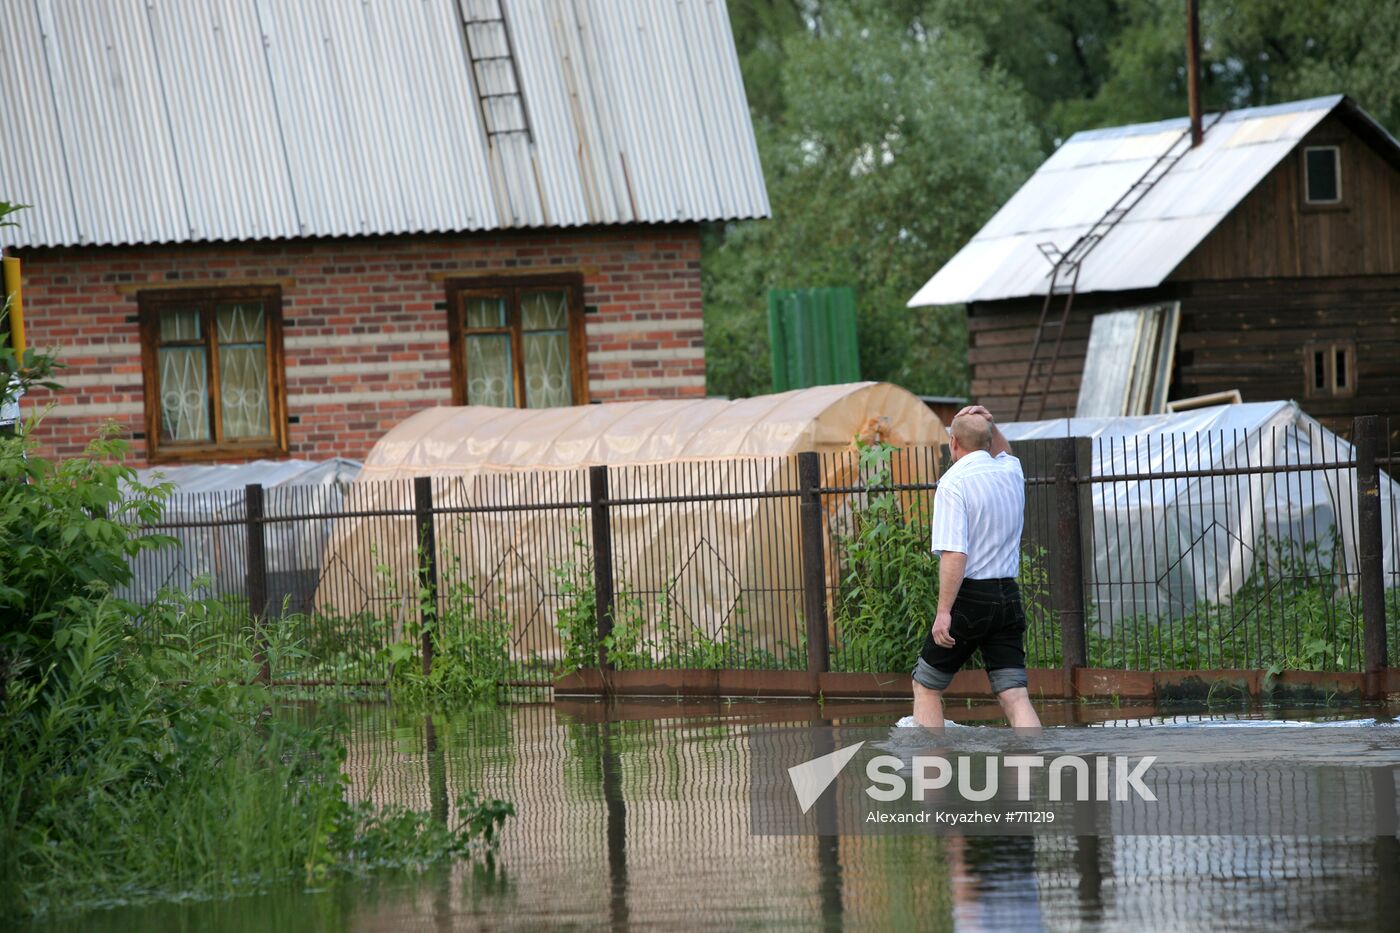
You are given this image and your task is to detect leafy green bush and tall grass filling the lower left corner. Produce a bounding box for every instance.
[0,423,512,919]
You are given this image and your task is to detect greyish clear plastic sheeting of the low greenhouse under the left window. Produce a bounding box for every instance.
[123,458,360,609]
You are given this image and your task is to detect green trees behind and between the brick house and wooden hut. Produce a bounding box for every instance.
[703,0,1400,396]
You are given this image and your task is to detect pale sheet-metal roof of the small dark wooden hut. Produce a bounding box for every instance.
[909,95,1396,307]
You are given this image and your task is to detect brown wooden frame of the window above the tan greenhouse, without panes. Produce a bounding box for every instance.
[447,273,588,408]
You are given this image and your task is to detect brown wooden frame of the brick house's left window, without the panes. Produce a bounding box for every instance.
[136,286,288,462]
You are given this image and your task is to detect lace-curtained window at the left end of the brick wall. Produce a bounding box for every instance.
[139,287,287,459]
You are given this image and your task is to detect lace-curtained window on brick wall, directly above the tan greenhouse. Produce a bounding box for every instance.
[448,275,588,408]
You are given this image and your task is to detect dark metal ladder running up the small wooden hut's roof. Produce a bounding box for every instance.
[1016,111,1225,422]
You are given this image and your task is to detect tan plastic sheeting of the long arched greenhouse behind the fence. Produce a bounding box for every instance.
[316,382,948,657]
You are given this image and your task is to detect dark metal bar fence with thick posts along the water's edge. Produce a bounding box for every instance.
[127,419,1400,685]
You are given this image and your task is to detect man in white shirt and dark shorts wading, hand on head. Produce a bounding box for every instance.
[914,405,1040,728]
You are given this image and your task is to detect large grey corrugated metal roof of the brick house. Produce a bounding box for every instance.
[0,0,769,247]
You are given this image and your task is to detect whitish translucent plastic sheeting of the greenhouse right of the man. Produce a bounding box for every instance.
[1002,402,1400,625]
